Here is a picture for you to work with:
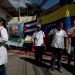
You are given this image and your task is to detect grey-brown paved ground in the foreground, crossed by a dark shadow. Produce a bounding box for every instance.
[6,49,72,75]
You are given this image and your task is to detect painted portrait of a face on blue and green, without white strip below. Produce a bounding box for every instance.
[7,22,24,42]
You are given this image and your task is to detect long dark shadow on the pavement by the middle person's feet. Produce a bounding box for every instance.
[20,57,53,75]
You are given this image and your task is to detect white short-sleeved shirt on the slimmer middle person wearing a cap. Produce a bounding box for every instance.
[33,30,45,46]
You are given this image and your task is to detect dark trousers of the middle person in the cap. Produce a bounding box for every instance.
[35,46,44,62]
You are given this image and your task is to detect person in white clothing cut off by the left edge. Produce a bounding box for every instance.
[0,18,8,75]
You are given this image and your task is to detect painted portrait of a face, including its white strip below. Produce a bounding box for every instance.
[7,22,24,46]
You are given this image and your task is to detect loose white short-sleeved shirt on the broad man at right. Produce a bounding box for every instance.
[50,29,67,49]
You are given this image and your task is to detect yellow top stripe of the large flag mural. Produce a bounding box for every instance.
[38,4,75,25]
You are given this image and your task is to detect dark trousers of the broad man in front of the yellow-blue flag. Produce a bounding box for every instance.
[51,48,63,69]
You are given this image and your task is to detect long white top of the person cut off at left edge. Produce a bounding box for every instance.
[0,26,8,65]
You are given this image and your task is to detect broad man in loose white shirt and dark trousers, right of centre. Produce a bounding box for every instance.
[49,22,68,72]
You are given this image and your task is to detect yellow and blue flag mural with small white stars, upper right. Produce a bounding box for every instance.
[38,4,75,32]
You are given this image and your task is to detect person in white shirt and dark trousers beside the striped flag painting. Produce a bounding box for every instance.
[33,25,45,62]
